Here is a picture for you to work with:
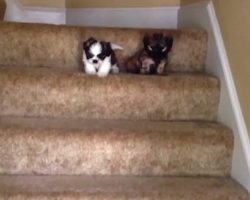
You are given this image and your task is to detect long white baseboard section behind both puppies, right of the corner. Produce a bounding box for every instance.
[66,7,179,28]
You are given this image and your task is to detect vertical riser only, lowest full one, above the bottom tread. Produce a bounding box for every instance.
[0,128,233,176]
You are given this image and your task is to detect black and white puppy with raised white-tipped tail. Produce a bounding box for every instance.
[82,37,122,77]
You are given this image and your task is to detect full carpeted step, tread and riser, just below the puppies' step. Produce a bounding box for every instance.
[0,117,233,176]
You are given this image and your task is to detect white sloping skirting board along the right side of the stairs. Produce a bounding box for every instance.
[178,1,250,192]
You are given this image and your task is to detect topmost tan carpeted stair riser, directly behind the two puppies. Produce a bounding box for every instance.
[0,22,208,72]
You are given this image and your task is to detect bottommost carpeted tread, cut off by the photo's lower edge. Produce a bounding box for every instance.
[0,176,250,200]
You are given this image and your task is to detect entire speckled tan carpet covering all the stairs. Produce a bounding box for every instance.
[0,22,250,200]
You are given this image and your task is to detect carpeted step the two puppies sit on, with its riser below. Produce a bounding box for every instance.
[0,67,220,120]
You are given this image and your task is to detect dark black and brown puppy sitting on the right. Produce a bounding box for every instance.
[125,34,173,74]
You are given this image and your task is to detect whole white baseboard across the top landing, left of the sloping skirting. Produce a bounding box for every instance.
[5,0,180,28]
